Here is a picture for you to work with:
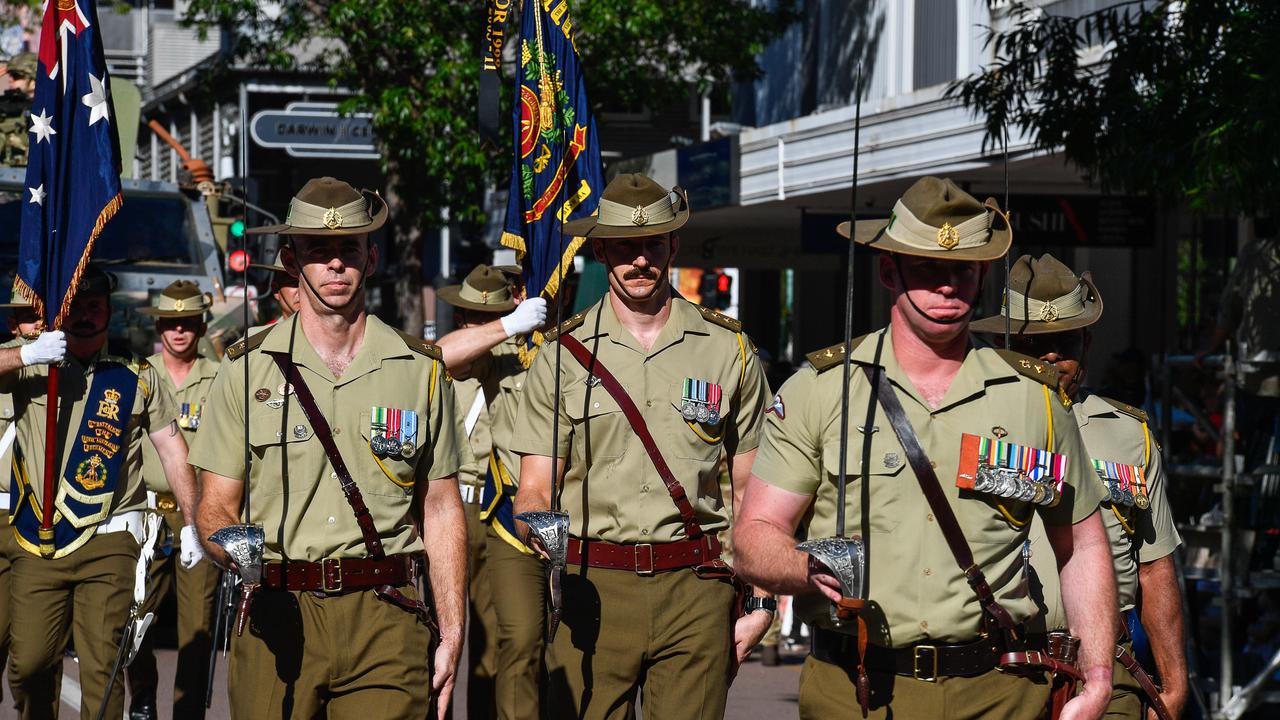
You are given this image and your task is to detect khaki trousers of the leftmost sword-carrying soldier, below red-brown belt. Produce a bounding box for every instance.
[227,585,431,720]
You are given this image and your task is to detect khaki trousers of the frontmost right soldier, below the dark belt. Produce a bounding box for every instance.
[800,655,1051,720]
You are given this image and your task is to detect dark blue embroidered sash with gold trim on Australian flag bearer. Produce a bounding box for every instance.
[9,363,138,557]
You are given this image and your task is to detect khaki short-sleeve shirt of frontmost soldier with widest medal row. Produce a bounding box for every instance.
[754,329,1102,647]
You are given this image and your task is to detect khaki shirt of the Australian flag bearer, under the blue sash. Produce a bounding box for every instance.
[0,348,178,515]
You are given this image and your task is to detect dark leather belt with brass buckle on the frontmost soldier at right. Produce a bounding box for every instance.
[810,628,1044,682]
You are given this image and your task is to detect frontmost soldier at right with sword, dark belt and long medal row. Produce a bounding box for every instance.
[735,178,1115,719]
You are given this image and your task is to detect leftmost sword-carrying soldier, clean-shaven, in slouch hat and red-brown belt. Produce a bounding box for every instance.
[191,178,466,719]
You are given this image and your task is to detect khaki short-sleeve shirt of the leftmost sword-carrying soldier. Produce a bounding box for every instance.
[189,315,460,561]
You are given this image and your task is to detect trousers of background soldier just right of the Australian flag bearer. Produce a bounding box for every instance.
[125,512,220,720]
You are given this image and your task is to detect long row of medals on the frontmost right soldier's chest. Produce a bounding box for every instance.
[956,433,1066,506]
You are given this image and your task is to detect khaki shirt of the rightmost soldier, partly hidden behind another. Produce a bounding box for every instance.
[1032,393,1183,629]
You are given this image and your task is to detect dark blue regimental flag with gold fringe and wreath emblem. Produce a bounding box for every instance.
[502,0,604,313]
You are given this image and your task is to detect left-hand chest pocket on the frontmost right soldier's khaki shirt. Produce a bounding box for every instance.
[822,428,920,533]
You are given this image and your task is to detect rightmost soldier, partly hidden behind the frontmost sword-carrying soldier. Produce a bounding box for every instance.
[972,255,1187,720]
